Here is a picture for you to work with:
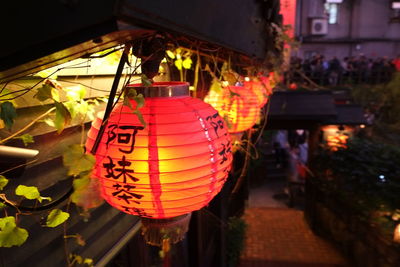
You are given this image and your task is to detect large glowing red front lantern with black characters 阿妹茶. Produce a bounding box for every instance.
[86,82,232,245]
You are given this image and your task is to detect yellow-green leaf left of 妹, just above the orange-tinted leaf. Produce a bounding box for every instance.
[63,144,95,175]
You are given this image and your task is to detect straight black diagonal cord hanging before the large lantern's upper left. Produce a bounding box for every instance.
[90,44,131,155]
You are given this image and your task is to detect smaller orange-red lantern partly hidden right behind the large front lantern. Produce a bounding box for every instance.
[204,86,260,133]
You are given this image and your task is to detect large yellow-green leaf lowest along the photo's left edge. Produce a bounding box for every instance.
[0,216,29,248]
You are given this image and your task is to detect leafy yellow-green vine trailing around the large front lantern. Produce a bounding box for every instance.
[0,26,288,266]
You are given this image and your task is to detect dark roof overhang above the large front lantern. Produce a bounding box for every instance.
[0,0,279,83]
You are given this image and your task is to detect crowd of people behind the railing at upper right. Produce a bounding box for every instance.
[284,54,400,86]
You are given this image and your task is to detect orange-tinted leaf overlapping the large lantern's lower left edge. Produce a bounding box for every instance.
[71,175,104,210]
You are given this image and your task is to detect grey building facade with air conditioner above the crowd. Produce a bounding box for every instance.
[294,0,400,59]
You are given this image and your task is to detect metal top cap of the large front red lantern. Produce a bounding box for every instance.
[125,82,189,97]
